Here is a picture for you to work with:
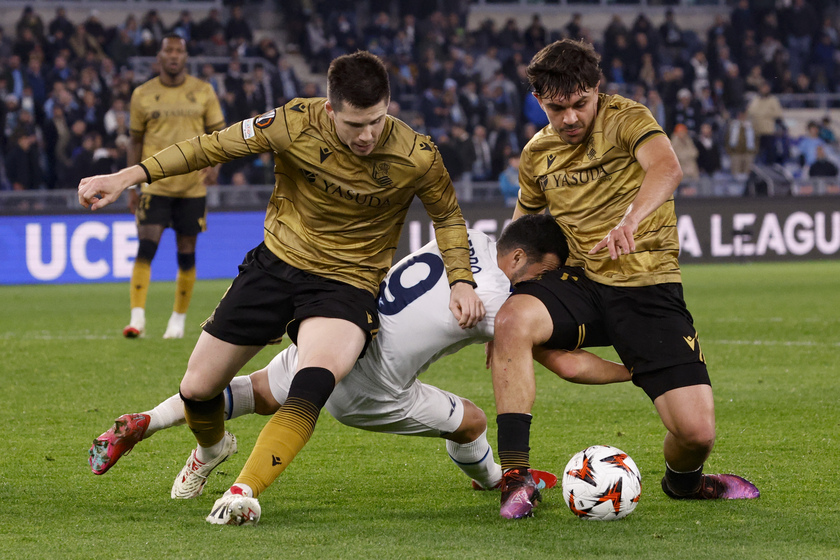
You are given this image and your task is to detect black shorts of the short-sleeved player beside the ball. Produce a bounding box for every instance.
[514,267,711,400]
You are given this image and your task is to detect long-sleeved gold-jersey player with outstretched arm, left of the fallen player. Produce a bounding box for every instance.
[79,52,485,520]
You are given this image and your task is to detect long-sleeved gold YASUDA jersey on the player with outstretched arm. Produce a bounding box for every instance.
[141,98,473,294]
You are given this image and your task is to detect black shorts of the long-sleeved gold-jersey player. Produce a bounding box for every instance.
[202,243,379,355]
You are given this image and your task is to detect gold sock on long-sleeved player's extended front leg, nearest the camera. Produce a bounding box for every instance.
[236,397,320,498]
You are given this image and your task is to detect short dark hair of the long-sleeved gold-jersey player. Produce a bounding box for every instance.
[327,51,391,110]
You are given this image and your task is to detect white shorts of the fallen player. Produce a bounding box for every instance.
[268,346,464,437]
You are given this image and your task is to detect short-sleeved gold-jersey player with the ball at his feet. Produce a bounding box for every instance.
[491,40,759,518]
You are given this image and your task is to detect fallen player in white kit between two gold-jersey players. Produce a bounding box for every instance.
[90,215,630,524]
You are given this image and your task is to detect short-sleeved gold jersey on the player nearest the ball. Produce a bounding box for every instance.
[517,94,681,286]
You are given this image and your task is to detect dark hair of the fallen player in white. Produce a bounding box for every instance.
[496,214,569,264]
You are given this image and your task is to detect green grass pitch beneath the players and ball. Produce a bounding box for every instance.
[0,261,840,560]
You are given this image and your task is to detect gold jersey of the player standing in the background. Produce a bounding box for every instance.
[130,75,225,198]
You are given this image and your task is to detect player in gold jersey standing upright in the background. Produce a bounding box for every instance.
[123,35,225,338]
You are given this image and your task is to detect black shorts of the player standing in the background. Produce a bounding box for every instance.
[134,193,207,236]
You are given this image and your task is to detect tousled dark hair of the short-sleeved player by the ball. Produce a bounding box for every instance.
[527,39,601,99]
